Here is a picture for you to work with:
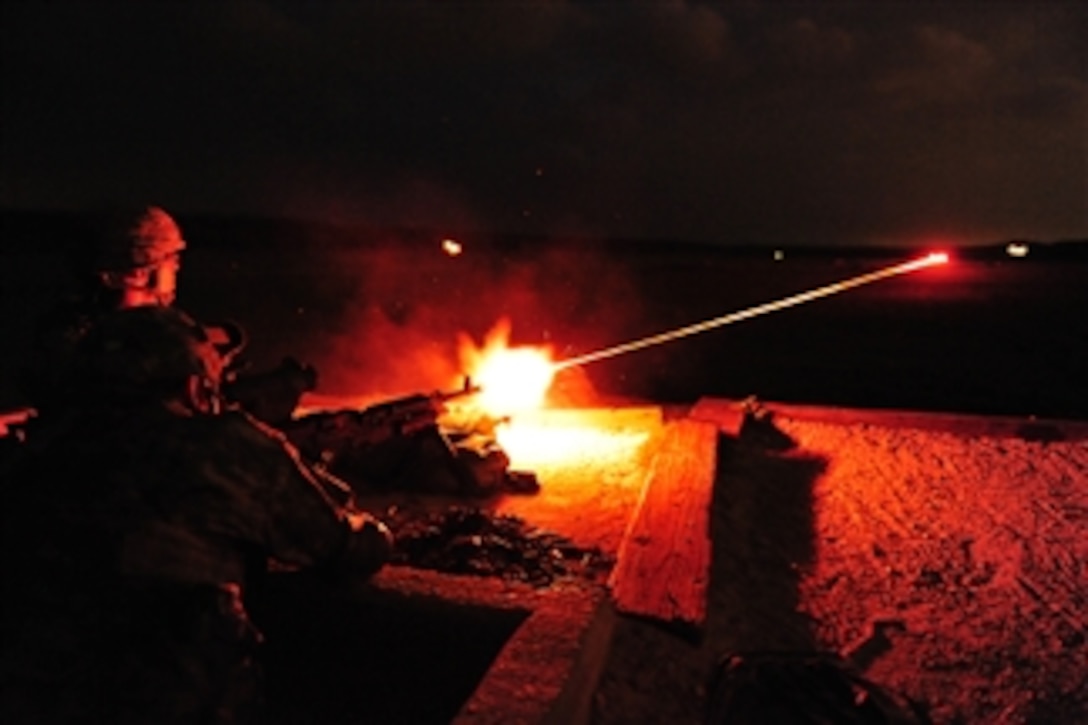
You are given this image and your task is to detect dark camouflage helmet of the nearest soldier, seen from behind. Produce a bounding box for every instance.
[77,306,223,397]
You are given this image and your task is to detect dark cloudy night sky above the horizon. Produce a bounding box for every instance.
[0,0,1088,245]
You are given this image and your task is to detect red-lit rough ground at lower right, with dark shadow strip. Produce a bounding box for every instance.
[594,409,1088,724]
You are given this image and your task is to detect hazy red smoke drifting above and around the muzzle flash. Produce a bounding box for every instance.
[310,231,641,402]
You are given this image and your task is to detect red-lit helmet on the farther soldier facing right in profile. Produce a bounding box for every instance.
[95,207,185,272]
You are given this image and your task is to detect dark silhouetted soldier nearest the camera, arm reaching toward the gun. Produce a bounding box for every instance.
[0,306,392,723]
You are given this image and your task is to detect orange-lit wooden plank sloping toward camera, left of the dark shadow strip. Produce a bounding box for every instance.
[608,419,718,628]
